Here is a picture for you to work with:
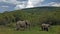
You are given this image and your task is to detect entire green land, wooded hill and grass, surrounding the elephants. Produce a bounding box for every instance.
[0,7,60,34]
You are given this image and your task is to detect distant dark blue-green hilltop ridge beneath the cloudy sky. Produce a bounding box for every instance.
[22,7,60,12]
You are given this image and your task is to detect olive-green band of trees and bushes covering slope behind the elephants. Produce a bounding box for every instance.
[0,8,60,26]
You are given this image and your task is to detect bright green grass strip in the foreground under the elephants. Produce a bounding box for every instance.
[0,26,60,34]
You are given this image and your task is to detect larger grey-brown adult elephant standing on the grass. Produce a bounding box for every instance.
[16,20,30,30]
